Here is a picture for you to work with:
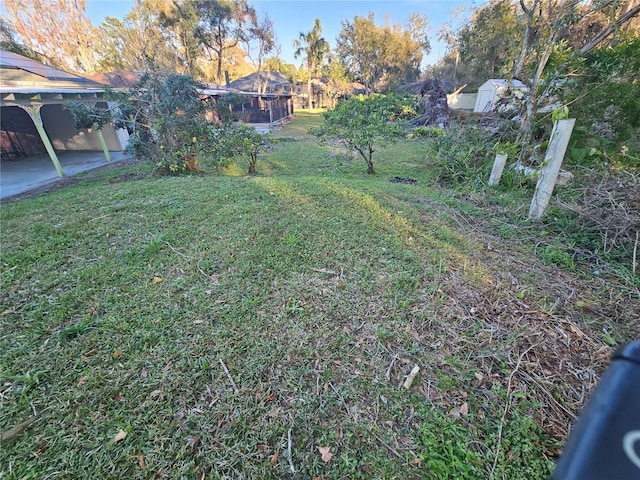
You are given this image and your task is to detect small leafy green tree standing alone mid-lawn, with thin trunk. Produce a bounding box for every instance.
[311,95,415,174]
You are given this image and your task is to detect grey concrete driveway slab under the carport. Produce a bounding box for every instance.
[0,152,131,199]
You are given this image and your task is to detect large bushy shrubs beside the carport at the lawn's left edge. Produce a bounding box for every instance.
[111,72,271,175]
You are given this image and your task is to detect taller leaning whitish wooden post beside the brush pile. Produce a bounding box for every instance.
[528,118,576,220]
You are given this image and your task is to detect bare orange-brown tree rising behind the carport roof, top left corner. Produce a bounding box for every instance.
[4,0,97,73]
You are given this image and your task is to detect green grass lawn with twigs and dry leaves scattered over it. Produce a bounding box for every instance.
[0,113,638,480]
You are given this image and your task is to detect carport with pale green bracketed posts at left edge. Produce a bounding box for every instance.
[0,50,128,176]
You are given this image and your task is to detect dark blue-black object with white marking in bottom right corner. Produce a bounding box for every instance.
[551,341,640,480]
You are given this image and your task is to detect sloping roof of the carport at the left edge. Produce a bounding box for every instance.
[0,50,102,90]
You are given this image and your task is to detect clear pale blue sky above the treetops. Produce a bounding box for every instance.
[87,0,487,65]
